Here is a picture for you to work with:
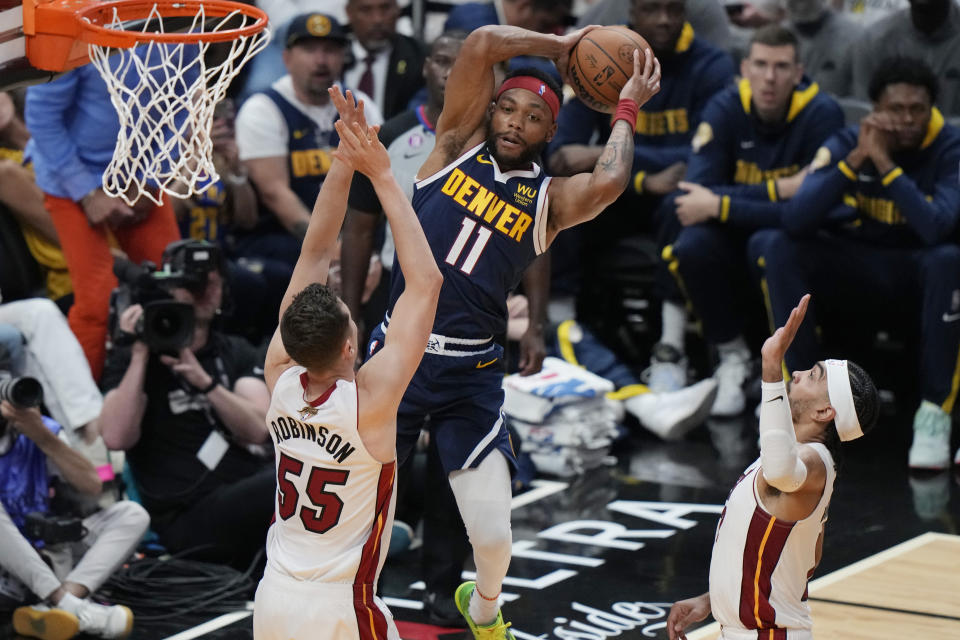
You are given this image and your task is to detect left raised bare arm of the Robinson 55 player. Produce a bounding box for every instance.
[263,87,366,393]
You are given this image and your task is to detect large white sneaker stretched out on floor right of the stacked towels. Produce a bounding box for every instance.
[623,378,717,440]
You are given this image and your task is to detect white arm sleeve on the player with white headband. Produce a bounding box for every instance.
[760,381,807,493]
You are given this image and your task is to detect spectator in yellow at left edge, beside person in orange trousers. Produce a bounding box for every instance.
[0,92,73,300]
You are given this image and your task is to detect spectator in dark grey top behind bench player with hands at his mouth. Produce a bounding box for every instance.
[853,0,960,117]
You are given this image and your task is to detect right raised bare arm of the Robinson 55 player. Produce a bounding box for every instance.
[344,122,443,461]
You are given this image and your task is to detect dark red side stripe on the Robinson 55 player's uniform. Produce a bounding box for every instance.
[353,461,397,640]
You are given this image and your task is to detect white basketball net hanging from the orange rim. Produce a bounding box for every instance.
[88,5,270,206]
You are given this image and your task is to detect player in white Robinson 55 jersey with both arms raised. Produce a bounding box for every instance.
[253,87,442,640]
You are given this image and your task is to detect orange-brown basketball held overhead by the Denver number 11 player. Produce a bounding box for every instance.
[567,26,650,113]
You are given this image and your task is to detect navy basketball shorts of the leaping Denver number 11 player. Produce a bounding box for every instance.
[367,324,517,474]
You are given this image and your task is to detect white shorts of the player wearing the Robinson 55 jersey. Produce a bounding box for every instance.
[253,569,400,640]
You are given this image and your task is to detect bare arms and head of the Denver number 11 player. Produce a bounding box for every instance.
[418,26,660,252]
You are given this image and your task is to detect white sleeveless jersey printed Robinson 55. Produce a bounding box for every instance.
[267,366,396,600]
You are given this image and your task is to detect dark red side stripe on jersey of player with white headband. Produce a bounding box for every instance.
[740,506,795,638]
